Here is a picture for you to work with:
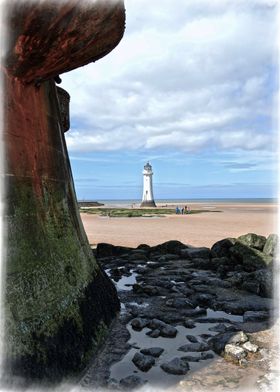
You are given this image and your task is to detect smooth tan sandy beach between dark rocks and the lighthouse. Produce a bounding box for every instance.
[81,203,277,247]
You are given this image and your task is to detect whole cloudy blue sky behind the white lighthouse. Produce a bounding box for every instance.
[61,0,278,200]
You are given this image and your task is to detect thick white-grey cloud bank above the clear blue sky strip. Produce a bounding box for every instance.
[62,0,277,156]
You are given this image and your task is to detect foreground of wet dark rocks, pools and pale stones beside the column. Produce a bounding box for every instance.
[81,233,279,391]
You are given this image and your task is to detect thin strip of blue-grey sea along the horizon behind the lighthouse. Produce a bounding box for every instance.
[79,198,277,205]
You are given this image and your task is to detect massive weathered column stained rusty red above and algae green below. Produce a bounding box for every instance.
[4,0,124,379]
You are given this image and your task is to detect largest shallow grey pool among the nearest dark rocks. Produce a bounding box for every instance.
[110,309,242,387]
